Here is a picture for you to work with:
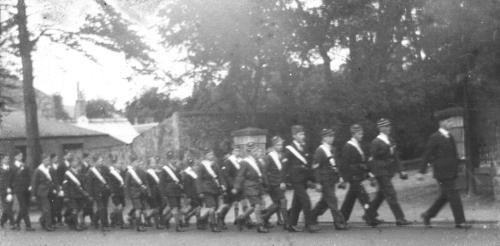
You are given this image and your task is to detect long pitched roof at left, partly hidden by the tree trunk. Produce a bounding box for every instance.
[0,111,107,139]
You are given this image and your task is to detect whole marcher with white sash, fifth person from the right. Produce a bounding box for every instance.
[285,125,319,232]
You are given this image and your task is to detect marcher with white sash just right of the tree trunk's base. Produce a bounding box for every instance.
[31,154,56,231]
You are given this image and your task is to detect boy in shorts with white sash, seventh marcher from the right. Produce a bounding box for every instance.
[231,143,269,233]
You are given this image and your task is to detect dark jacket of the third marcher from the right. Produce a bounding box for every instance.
[339,140,368,182]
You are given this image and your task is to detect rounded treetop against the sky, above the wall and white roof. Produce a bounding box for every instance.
[125,87,180,123]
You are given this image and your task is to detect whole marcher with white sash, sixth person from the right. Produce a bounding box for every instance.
[262,136,288,230]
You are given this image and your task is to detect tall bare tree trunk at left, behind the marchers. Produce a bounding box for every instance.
[17,0,42,167]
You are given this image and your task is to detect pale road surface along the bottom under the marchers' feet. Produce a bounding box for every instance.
[0,223,500,246]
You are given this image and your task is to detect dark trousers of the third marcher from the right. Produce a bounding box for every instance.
[340,181,370,221]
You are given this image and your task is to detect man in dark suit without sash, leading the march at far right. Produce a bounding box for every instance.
[418,111,471,229]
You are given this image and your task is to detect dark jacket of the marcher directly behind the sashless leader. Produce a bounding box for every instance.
[369,138,401,177]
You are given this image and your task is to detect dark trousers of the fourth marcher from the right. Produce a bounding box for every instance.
[312,182,345,224]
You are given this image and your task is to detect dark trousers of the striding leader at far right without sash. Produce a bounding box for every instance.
[425,179,465,224]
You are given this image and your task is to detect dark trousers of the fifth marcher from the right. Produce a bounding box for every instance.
[288,183,313,226]
